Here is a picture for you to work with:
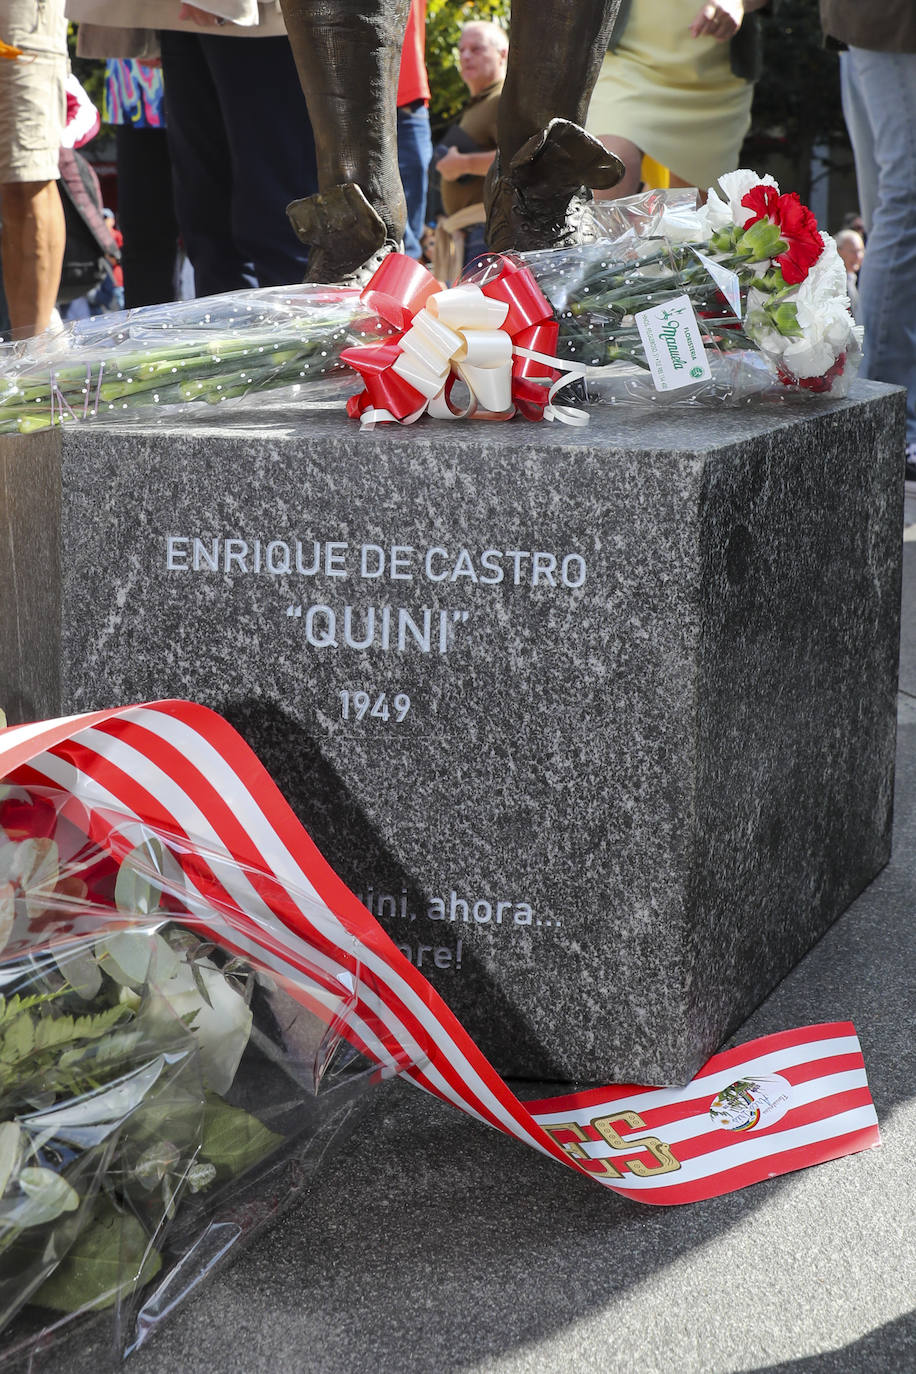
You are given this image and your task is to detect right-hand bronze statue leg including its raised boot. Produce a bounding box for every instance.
[486,0,623,251]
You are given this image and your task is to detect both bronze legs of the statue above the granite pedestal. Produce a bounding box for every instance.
[280,0,623,282]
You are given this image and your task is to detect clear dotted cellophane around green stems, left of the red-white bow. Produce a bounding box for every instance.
[0,286,390,434]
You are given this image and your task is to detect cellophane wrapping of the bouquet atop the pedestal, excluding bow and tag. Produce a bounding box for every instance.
[0,170,861,434]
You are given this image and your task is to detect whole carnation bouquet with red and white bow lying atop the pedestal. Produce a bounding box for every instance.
[0,170,861,433]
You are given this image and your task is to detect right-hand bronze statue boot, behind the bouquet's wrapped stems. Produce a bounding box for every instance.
[483,120,625,253]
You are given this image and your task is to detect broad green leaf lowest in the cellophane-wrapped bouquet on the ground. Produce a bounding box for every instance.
[30,1198,162,1312]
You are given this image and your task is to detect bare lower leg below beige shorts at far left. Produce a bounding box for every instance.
[0,181,66,339]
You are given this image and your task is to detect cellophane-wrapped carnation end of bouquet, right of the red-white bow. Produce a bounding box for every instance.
[525,172,862,405]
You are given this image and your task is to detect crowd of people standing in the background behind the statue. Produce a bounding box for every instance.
[0,0,916,480]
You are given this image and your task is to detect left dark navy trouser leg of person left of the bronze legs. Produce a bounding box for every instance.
[159,29,254,295]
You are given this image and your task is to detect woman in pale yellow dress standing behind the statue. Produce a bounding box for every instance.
[586,0,768,199]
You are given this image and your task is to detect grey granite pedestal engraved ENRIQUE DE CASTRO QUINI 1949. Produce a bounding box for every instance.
[0,383,902,1083]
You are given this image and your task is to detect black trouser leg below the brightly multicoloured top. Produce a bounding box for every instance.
[115,124,179,311]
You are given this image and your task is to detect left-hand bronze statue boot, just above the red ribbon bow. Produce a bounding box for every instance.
[286,181,401,286]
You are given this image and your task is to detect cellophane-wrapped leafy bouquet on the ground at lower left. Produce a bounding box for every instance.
[0,785,392,1369]
